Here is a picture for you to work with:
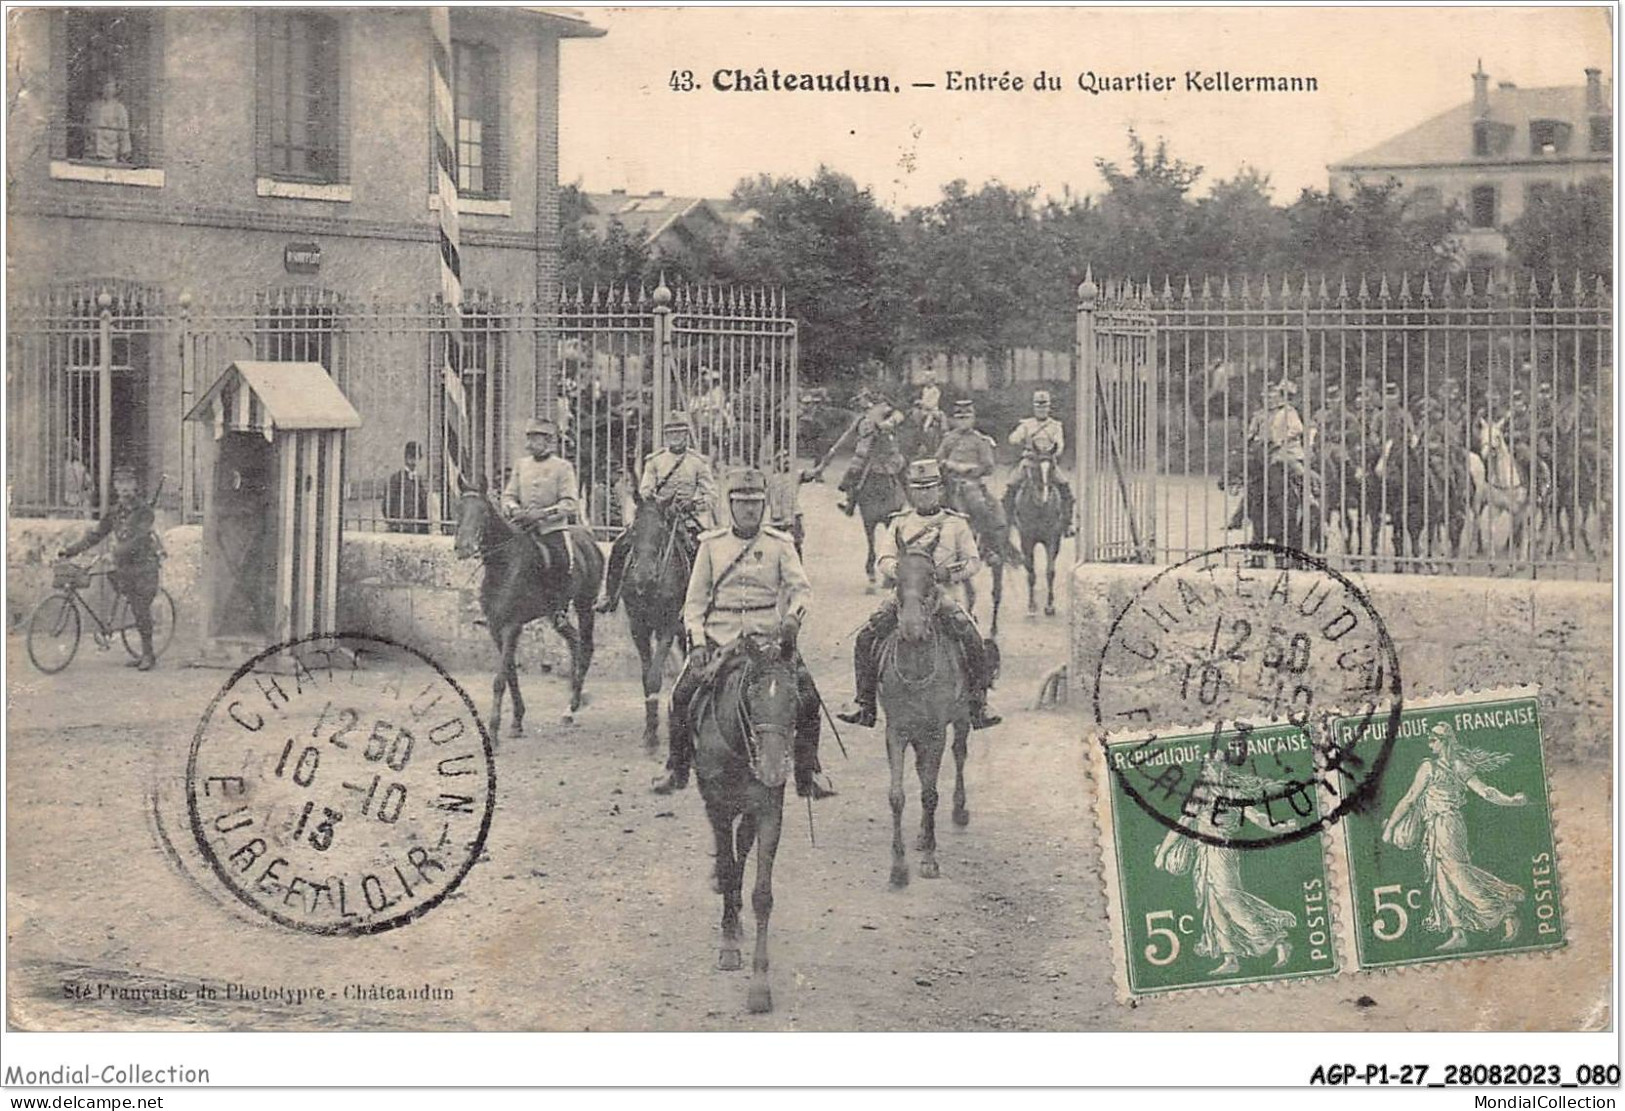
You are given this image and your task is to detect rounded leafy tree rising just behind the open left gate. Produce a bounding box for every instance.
[733,166,904,385]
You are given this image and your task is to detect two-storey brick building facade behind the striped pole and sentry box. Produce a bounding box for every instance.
[7,8,601,513]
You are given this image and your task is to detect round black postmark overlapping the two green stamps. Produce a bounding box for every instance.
[1094,543,1402,848]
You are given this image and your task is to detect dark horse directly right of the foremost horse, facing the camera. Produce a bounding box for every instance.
[878,552,970,887]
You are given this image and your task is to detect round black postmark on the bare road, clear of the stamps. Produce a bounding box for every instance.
[185,633,496,936]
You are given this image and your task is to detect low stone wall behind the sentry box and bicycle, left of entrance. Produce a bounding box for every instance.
[7,520,639,679]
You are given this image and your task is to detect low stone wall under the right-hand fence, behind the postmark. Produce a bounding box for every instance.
[1068,564,1614,763]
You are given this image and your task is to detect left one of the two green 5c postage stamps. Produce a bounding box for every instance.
[1095,724,1337,999]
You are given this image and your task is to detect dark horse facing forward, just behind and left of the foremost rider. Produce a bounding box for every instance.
[621,497,691,750]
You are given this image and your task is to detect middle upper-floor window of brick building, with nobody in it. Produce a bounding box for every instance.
[255,11,348,182]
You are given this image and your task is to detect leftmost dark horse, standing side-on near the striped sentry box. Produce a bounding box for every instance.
[457,491,605,737]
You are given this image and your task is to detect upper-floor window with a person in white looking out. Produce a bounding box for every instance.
[52,8,163,167]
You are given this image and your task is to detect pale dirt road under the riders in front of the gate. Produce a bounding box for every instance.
[7,486,1612,1030]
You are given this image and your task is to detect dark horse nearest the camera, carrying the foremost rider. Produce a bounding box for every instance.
[692,637,798,1014]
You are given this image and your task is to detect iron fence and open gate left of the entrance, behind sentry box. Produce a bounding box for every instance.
[7,283,796,534]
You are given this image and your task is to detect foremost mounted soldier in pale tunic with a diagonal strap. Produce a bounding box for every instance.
[653,469,835,799]
